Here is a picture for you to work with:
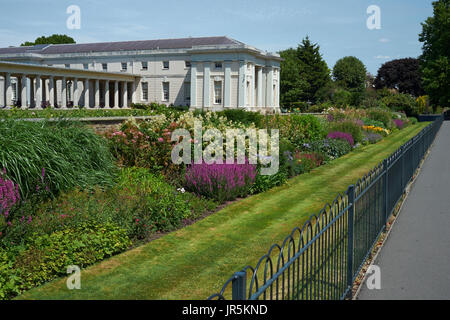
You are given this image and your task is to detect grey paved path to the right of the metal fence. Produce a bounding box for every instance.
[357,121,450,300]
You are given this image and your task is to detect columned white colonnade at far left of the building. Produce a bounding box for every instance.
[0,62,140,109]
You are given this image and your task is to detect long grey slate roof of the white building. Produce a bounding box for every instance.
[0,36,245,54]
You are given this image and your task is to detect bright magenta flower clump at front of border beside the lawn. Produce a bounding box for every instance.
[186,161,256,202]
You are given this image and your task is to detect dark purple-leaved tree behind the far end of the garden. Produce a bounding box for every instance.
[375,58,423,97]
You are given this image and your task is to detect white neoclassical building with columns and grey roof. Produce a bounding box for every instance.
[0,37,281,112]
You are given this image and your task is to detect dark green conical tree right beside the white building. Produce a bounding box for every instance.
[280,37,330,106]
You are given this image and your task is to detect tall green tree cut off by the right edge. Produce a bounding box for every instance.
[419,0,450,107]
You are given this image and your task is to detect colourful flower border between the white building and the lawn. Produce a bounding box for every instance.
[0,104,416,299]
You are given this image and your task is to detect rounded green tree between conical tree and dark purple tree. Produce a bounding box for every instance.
[333,57,367,105]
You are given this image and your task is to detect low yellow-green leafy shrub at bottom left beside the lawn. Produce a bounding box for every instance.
[14,223,131,290]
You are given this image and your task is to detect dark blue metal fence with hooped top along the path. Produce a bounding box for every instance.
[208,117,443,300]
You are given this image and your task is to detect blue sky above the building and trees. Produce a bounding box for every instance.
[0,0,433,74]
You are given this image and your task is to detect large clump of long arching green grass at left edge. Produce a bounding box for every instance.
[0,120,116,198]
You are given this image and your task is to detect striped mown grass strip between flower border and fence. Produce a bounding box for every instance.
[19,123,428,299]
